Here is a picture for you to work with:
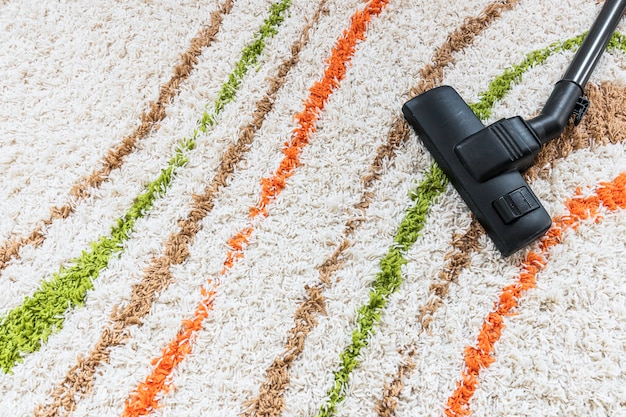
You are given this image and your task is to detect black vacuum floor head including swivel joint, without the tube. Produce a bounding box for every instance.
[402,86,552,256]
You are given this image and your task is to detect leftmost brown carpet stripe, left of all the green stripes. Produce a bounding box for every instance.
[0,0,234,271]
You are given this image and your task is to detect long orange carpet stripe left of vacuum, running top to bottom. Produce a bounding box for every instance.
[122,0,389,417]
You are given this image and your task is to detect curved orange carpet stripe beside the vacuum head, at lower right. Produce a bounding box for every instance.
[445,173,626,417]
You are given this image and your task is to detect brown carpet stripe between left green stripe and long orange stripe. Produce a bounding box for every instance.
[35,0,326,417]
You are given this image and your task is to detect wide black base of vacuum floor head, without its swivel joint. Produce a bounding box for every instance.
[402,86,552,256]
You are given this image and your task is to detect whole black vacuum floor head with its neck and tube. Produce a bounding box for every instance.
[402,0,626,256]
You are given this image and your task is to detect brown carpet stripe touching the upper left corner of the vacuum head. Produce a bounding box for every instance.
[241,0,518,417]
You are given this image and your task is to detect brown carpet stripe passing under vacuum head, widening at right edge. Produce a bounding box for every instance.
[377,82,626,417]
